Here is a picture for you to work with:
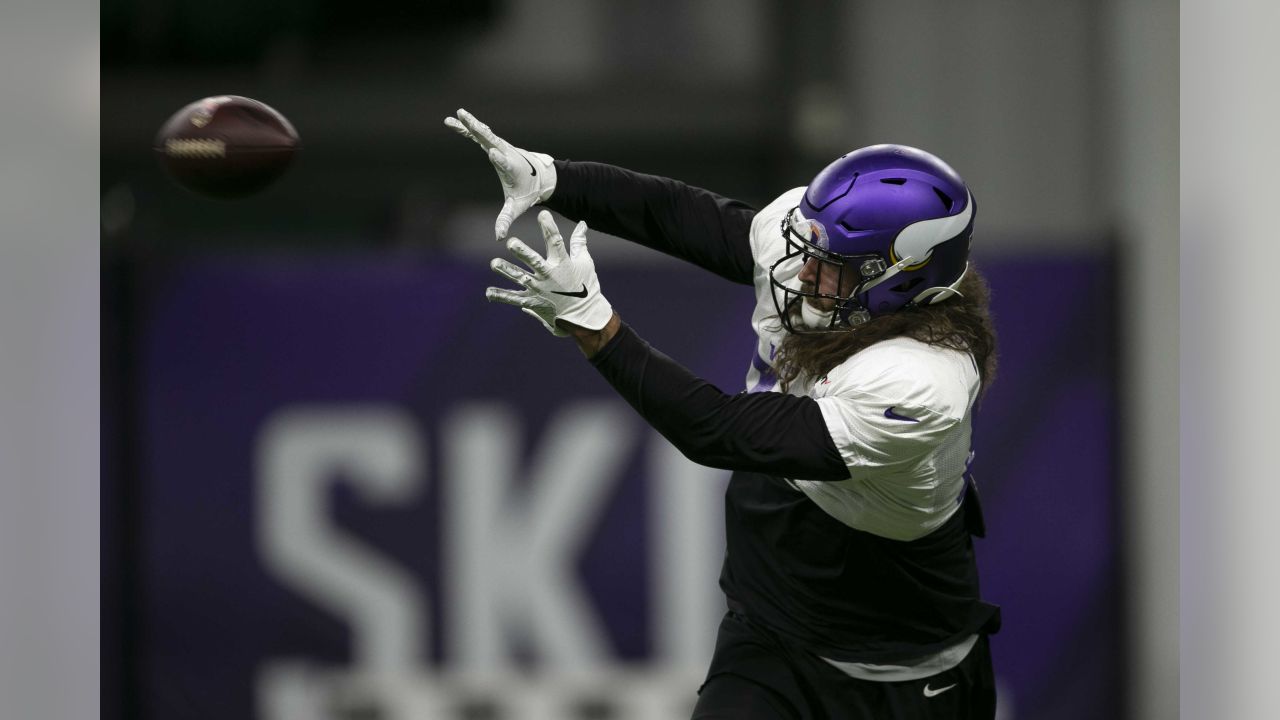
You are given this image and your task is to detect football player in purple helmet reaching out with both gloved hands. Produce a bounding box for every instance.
[445,110,1000,720]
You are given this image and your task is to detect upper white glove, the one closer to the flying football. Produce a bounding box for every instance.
[444,109,556,240]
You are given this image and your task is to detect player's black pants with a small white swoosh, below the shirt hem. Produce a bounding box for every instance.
[692,612,996,720]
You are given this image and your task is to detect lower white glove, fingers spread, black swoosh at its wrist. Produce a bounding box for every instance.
[484,210,613,337]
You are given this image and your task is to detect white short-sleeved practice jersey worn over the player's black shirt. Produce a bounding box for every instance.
[746,187,979,541]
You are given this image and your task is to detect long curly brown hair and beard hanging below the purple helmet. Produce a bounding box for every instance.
[773,264,996,393]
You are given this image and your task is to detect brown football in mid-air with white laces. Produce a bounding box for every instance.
[155,95,298,197]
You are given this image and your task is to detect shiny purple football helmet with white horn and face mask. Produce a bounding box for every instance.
[769,145,974,333]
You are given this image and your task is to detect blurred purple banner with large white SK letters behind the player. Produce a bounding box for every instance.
[138,256,1120,720]
